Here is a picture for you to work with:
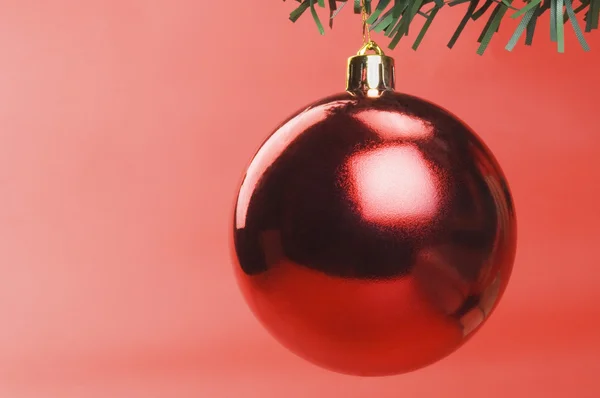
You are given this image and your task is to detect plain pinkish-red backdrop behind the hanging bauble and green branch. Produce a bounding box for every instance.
[0,0,600,398]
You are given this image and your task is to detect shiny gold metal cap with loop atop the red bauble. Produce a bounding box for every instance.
[346,41,396,98]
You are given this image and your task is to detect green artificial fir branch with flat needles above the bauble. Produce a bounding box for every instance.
[283,0,600,55]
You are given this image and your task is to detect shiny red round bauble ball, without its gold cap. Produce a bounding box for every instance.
[233,92,516,376]
